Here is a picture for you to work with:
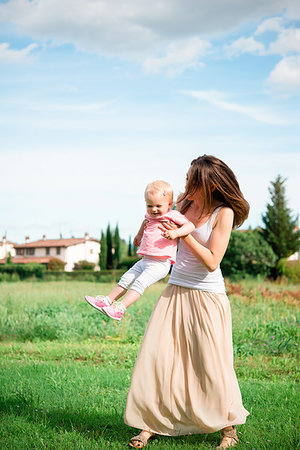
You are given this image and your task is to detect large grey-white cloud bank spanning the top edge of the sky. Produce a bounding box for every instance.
[0,0,298,60]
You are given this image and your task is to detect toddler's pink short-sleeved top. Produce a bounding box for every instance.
[138,209,188,264]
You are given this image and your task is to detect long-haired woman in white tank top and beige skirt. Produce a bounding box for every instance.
[125,155,249,448]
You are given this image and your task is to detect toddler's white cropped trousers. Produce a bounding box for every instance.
[118,256,171,295]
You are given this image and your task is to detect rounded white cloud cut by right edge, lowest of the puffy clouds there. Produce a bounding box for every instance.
[268,55,300,91]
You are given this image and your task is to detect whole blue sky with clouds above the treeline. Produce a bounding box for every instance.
[0,0,300,243]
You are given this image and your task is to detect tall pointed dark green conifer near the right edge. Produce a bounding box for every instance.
[261,175,300,264]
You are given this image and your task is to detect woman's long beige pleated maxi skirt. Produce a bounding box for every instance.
[124,284,249,436]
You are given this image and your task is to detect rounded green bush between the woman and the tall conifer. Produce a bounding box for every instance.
[221,230,276,277]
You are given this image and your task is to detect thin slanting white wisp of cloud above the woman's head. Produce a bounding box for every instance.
[182,91,285,125]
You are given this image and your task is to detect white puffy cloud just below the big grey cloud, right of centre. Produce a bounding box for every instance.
[144,37,211,76]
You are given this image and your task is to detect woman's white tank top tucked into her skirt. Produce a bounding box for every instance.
[169,206,225,294]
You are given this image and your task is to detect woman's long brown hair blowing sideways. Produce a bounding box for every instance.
[179,155,249,228]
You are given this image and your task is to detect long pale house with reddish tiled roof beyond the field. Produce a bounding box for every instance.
[0,233,100,272]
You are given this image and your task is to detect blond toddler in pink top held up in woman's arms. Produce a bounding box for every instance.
[85,181,195,320]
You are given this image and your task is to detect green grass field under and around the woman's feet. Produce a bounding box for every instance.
[0,281,300,449]
